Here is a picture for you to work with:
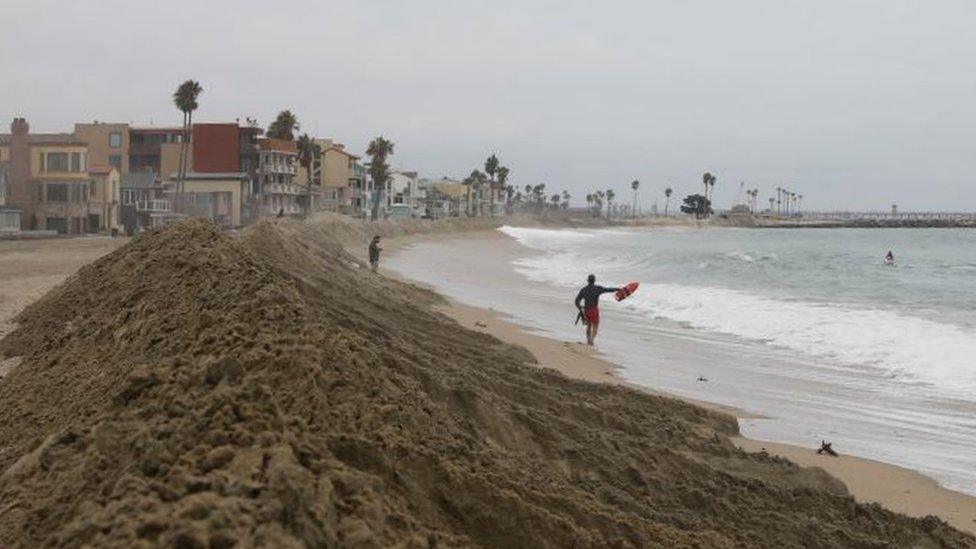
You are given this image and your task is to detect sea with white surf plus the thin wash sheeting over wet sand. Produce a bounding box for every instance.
[388,227,976,495]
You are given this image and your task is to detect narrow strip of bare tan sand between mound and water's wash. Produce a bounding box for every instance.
[378,225,976,534]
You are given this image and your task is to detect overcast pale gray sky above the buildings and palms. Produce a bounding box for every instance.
[0,0,976,211]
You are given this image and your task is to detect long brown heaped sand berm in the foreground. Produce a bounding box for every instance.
[0,221,974,547]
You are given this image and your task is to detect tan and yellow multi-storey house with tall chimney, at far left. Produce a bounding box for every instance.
[0,118,89,234]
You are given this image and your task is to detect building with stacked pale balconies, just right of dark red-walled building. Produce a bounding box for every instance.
[257,138,307,217]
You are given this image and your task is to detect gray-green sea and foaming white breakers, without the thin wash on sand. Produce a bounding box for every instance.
[502,227,976,399]
